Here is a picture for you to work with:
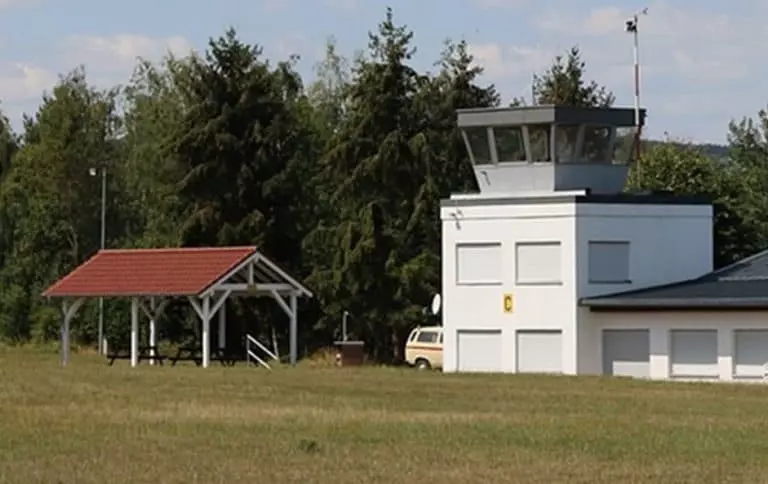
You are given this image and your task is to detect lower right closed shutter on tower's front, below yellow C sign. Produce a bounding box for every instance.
[517,331,563,373]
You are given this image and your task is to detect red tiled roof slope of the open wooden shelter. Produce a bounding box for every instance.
[43,247,256,297]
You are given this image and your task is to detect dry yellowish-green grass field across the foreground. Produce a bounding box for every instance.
[0,349,768,484]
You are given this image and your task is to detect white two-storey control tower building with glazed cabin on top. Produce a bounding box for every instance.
[440,106,713,375]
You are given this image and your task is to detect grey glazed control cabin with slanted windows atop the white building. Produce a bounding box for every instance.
[457,106,645,195]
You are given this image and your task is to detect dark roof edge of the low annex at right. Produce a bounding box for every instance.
[579,297,768,311]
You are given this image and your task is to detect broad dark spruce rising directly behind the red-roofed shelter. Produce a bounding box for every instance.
[170,29,316,352]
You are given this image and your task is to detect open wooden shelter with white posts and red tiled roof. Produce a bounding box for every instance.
[43,247,312,368]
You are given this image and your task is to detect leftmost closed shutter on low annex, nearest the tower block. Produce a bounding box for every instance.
[603,329,651,378]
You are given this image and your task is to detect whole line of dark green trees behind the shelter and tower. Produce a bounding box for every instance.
[0,9,768,361]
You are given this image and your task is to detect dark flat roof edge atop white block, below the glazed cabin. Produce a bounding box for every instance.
[440,193,712,207]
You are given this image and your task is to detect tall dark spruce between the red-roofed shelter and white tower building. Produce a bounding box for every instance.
[307,9,425,358]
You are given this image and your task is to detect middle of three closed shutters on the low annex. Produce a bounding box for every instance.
[670,330,719,378]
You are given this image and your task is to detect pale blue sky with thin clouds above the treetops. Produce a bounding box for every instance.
[0,0,768,143]
